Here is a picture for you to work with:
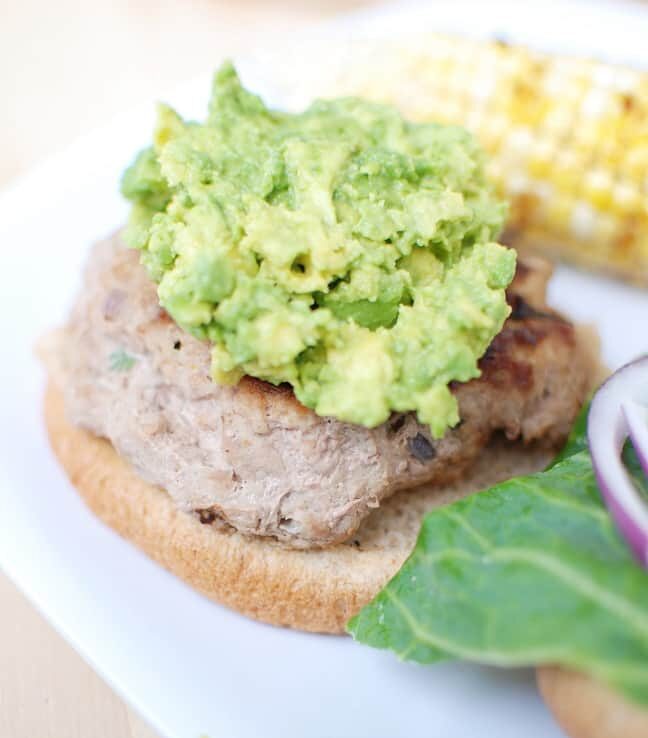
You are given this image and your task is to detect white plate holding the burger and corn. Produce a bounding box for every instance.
[0,0,648,738]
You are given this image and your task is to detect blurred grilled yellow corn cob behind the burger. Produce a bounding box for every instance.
[327,35,648,285]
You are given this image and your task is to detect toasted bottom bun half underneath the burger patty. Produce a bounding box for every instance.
[45,385,548,633]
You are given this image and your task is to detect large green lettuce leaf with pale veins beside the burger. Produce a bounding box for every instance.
[349,446,648,705]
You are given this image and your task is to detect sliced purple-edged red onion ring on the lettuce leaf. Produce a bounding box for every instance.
[587,356,648,568]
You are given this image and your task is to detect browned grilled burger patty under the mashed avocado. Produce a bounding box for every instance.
[46,234,590,548]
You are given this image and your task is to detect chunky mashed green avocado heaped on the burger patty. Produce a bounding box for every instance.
[122,65,515,437]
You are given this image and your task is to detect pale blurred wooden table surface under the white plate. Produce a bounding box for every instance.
[0,0,368,738]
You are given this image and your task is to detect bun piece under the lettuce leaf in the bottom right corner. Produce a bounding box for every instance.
[537,667,648,738]
